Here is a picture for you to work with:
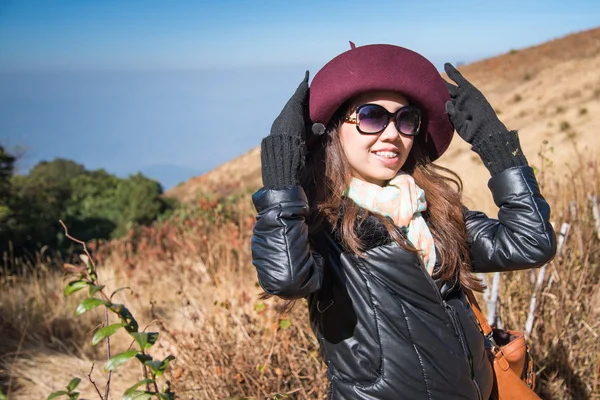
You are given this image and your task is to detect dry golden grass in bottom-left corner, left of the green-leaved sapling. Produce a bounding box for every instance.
[0,258,138,399]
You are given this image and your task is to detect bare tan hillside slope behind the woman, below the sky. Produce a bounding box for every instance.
[166,28,600,211]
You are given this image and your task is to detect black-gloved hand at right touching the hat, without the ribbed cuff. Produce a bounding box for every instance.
[444,63,508,143]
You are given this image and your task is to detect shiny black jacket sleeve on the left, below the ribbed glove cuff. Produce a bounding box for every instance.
[252,186,323,299]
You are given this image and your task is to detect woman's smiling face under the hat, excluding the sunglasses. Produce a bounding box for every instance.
[339,92,414,186]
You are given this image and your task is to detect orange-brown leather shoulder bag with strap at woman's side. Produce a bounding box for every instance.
[465,289,540,400]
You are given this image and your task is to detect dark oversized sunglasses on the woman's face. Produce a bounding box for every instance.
[344,104,421,136]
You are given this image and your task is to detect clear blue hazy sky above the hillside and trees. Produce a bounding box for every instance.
[0,0,600,187]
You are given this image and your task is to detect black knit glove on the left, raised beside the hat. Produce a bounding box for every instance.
[260,71,310,189]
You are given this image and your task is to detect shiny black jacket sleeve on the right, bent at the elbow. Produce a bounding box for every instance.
[464,166,556,272]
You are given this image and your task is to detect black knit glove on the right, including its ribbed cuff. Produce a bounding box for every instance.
[444,63,527,176]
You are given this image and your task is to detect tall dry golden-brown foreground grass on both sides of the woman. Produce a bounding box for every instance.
[0,155,600,400]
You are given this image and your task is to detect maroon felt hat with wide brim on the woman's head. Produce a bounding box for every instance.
[309,44,454,161]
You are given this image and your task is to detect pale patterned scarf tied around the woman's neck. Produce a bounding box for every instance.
[345,171,436,275]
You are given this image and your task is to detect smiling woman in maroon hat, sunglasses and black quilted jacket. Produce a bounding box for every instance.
[252,44,556,400]
